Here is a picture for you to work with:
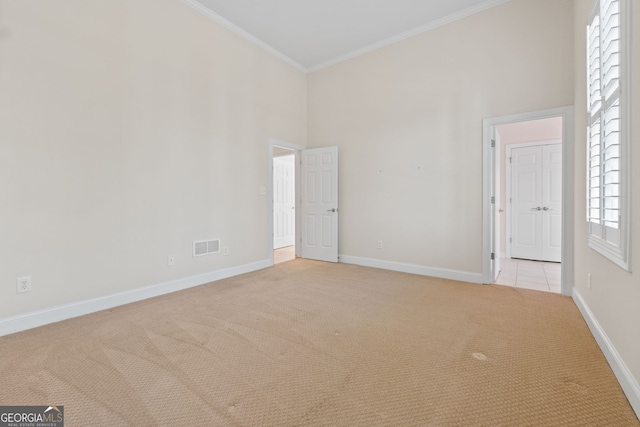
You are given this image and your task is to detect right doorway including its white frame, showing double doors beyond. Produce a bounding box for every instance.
[483,107,573,295]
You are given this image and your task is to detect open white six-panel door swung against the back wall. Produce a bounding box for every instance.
[300,147,338,262]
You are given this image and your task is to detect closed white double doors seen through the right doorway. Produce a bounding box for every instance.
[510,144,562,262]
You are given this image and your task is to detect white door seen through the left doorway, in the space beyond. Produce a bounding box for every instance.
[273,155,296,249]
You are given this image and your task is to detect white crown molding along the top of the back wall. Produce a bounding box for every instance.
[307,0,511,73]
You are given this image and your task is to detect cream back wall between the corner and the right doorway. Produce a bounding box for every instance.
[308,0,573,280]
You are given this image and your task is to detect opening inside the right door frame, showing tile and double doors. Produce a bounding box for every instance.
[493,116,563,293]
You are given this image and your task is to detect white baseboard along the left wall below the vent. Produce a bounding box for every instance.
[0,259,273,336]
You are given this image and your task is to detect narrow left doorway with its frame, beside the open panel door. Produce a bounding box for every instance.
[272,145,296,264]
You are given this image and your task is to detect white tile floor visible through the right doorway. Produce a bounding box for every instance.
[495,258,562,294]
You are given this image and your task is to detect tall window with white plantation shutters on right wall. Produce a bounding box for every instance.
[587,0,631,270]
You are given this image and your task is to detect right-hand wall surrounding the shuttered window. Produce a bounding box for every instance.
[574,0,640,414]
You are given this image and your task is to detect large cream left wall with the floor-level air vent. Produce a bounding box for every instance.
[0,0,306,320]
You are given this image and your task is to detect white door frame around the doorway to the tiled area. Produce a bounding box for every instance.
[482,106,575,296]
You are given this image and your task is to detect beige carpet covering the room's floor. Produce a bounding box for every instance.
[0,259,640,427]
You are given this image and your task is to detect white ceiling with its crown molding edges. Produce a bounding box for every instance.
[188,0,510,72]
